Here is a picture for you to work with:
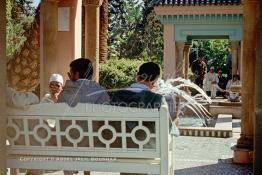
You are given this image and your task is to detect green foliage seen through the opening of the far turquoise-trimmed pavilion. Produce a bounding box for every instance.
[193,40,230,73]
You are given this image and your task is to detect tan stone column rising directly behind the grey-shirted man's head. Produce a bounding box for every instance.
[84,0,103,82]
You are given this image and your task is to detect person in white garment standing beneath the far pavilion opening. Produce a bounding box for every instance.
[204,66,218,99]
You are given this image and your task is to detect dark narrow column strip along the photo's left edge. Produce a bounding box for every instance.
[0,0,7,174]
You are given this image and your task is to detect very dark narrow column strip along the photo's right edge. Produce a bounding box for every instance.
[254,2,262,175]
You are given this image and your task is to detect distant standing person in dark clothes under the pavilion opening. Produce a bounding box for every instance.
[191,53,207,88]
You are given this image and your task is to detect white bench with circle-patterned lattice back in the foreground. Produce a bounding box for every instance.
[7,104,174,175]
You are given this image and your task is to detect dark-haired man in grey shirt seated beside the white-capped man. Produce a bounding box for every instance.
[58,58,109,106]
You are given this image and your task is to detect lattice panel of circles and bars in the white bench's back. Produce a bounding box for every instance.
[7,116,159,157]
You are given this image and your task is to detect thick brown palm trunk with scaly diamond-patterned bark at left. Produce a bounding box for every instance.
[7,8,40,91]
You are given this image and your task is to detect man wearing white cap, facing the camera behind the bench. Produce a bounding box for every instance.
[41,74,64,103]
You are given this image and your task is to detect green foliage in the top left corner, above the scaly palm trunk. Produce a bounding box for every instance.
[6,0,33,58]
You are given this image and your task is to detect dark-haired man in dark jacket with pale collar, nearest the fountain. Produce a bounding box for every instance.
[110,62,162,108]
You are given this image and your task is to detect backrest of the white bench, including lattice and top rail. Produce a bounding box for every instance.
[7,104,169,158]
